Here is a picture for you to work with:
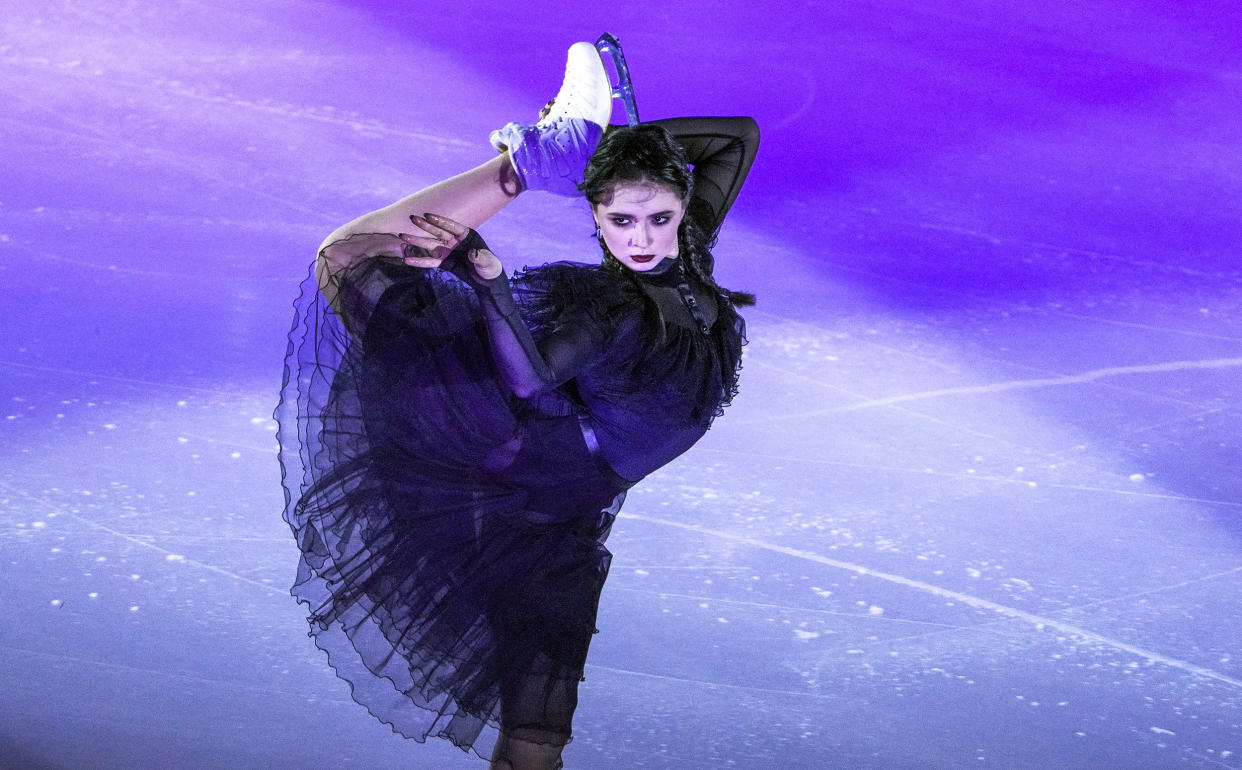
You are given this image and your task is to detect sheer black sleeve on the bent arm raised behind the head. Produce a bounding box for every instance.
[655,117,759,236]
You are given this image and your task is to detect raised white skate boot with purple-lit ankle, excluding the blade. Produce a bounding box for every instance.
[491,42,612,196]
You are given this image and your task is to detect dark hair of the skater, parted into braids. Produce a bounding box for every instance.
[580,123,755,307]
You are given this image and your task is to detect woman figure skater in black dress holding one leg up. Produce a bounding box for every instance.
[277,43,759,770]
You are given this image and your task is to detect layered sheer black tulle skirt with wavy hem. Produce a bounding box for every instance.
[276,249,623,755]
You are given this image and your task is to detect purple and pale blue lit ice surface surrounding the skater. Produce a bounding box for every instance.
[0,0,1242,770]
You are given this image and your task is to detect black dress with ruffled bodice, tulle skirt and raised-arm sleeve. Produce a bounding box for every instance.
[276,118,758,755]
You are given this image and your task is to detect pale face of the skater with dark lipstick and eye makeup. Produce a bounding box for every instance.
[595,183,686,273]
